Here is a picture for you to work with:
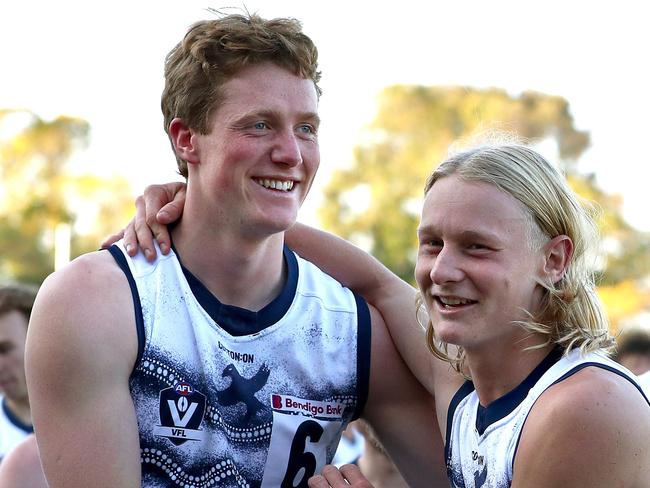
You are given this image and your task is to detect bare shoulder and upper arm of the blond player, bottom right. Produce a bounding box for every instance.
[512,367,650,488]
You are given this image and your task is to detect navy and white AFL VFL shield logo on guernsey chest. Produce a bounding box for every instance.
[154,383,206,446]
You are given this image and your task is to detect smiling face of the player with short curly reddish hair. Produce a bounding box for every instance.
[172,62,320,235]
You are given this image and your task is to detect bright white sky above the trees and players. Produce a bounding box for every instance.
[0,0,650,230]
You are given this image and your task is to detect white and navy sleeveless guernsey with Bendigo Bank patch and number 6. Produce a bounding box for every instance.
[110,243,370,488]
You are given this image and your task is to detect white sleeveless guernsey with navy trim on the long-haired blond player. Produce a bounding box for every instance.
[445,349,648,488]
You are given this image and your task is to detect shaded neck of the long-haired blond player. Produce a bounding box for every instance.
[466,337,554,406]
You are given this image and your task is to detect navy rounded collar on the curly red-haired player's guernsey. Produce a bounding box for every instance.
[174,246,298,336]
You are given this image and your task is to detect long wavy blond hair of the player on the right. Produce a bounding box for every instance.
[416,143,615,372]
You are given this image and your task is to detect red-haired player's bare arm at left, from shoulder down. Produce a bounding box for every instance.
[26,252,140,488]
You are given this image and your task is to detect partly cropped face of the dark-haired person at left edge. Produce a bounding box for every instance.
[0,310,27,402]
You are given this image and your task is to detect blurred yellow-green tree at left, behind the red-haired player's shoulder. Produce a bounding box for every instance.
[0,110,133,284]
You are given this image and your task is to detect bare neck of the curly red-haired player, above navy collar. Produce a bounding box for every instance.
[172,221,286,311]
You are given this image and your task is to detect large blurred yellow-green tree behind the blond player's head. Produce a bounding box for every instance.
[319,85,650,332]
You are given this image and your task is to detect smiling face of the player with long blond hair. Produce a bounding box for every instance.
[415,175,544,352]
